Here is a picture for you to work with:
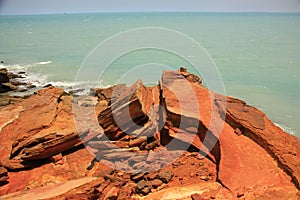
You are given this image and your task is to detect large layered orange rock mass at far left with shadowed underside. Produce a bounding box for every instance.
[0,87,104,167]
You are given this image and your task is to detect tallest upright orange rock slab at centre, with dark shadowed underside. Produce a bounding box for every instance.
[160,71,223,160]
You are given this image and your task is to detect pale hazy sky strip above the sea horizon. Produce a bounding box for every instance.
[0,0,300,15]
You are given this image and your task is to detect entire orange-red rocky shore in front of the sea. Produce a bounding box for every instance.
[0,69,300,200]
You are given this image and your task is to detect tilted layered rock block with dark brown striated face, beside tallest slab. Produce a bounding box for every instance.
[98,81,157,140]
